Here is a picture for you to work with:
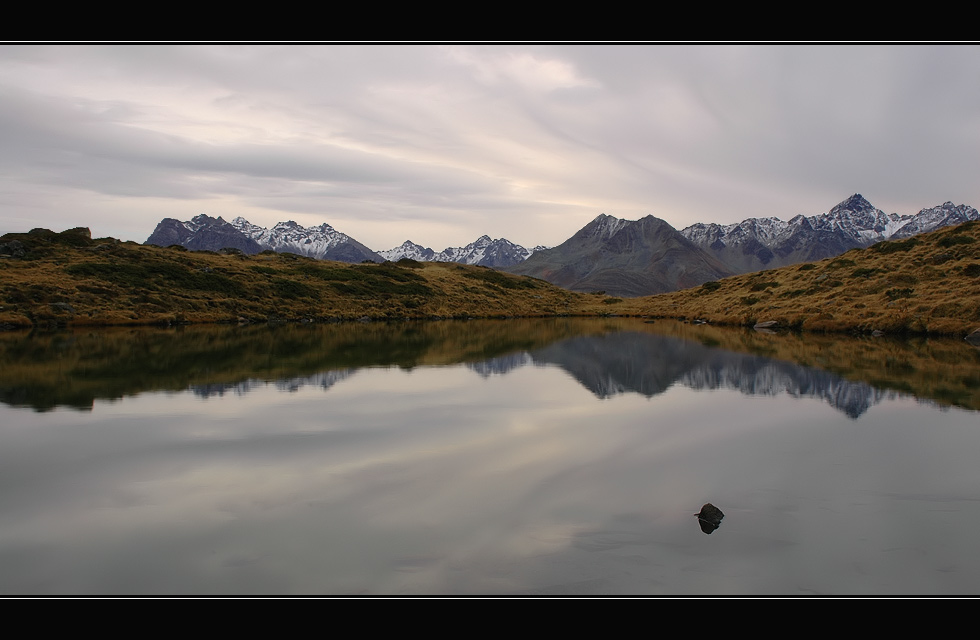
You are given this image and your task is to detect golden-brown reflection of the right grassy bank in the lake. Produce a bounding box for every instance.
[643,320,980,410]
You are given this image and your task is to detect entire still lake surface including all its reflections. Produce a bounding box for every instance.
[0,318,980,596]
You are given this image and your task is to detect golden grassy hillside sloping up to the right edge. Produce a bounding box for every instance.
[622,222,980,335]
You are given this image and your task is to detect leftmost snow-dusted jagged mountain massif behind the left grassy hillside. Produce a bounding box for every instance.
[145,214,384,262]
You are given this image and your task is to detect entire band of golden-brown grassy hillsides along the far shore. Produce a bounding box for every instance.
[0,222,980,337]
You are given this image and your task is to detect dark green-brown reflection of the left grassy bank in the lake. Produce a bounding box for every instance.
[0,319,624,409]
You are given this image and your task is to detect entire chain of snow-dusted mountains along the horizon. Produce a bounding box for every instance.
[146,194,980,297]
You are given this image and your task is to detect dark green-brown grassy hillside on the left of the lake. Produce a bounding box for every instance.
[0,228,616,328]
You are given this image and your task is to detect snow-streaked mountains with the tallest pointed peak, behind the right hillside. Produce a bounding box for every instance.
[681,194,980,273]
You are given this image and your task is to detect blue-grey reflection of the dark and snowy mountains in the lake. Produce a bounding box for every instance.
[470,332,898,418]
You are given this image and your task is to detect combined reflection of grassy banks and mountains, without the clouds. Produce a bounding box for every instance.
[0,318,968,417]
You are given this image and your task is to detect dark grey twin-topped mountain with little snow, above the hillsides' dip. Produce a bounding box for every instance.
[506,214,735,297]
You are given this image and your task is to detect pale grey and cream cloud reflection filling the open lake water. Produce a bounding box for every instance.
[0,350,980,595]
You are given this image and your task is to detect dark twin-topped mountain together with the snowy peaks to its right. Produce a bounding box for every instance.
[506,194,980,297]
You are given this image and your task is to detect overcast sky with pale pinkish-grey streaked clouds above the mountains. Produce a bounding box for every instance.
[0,43,980,251]
